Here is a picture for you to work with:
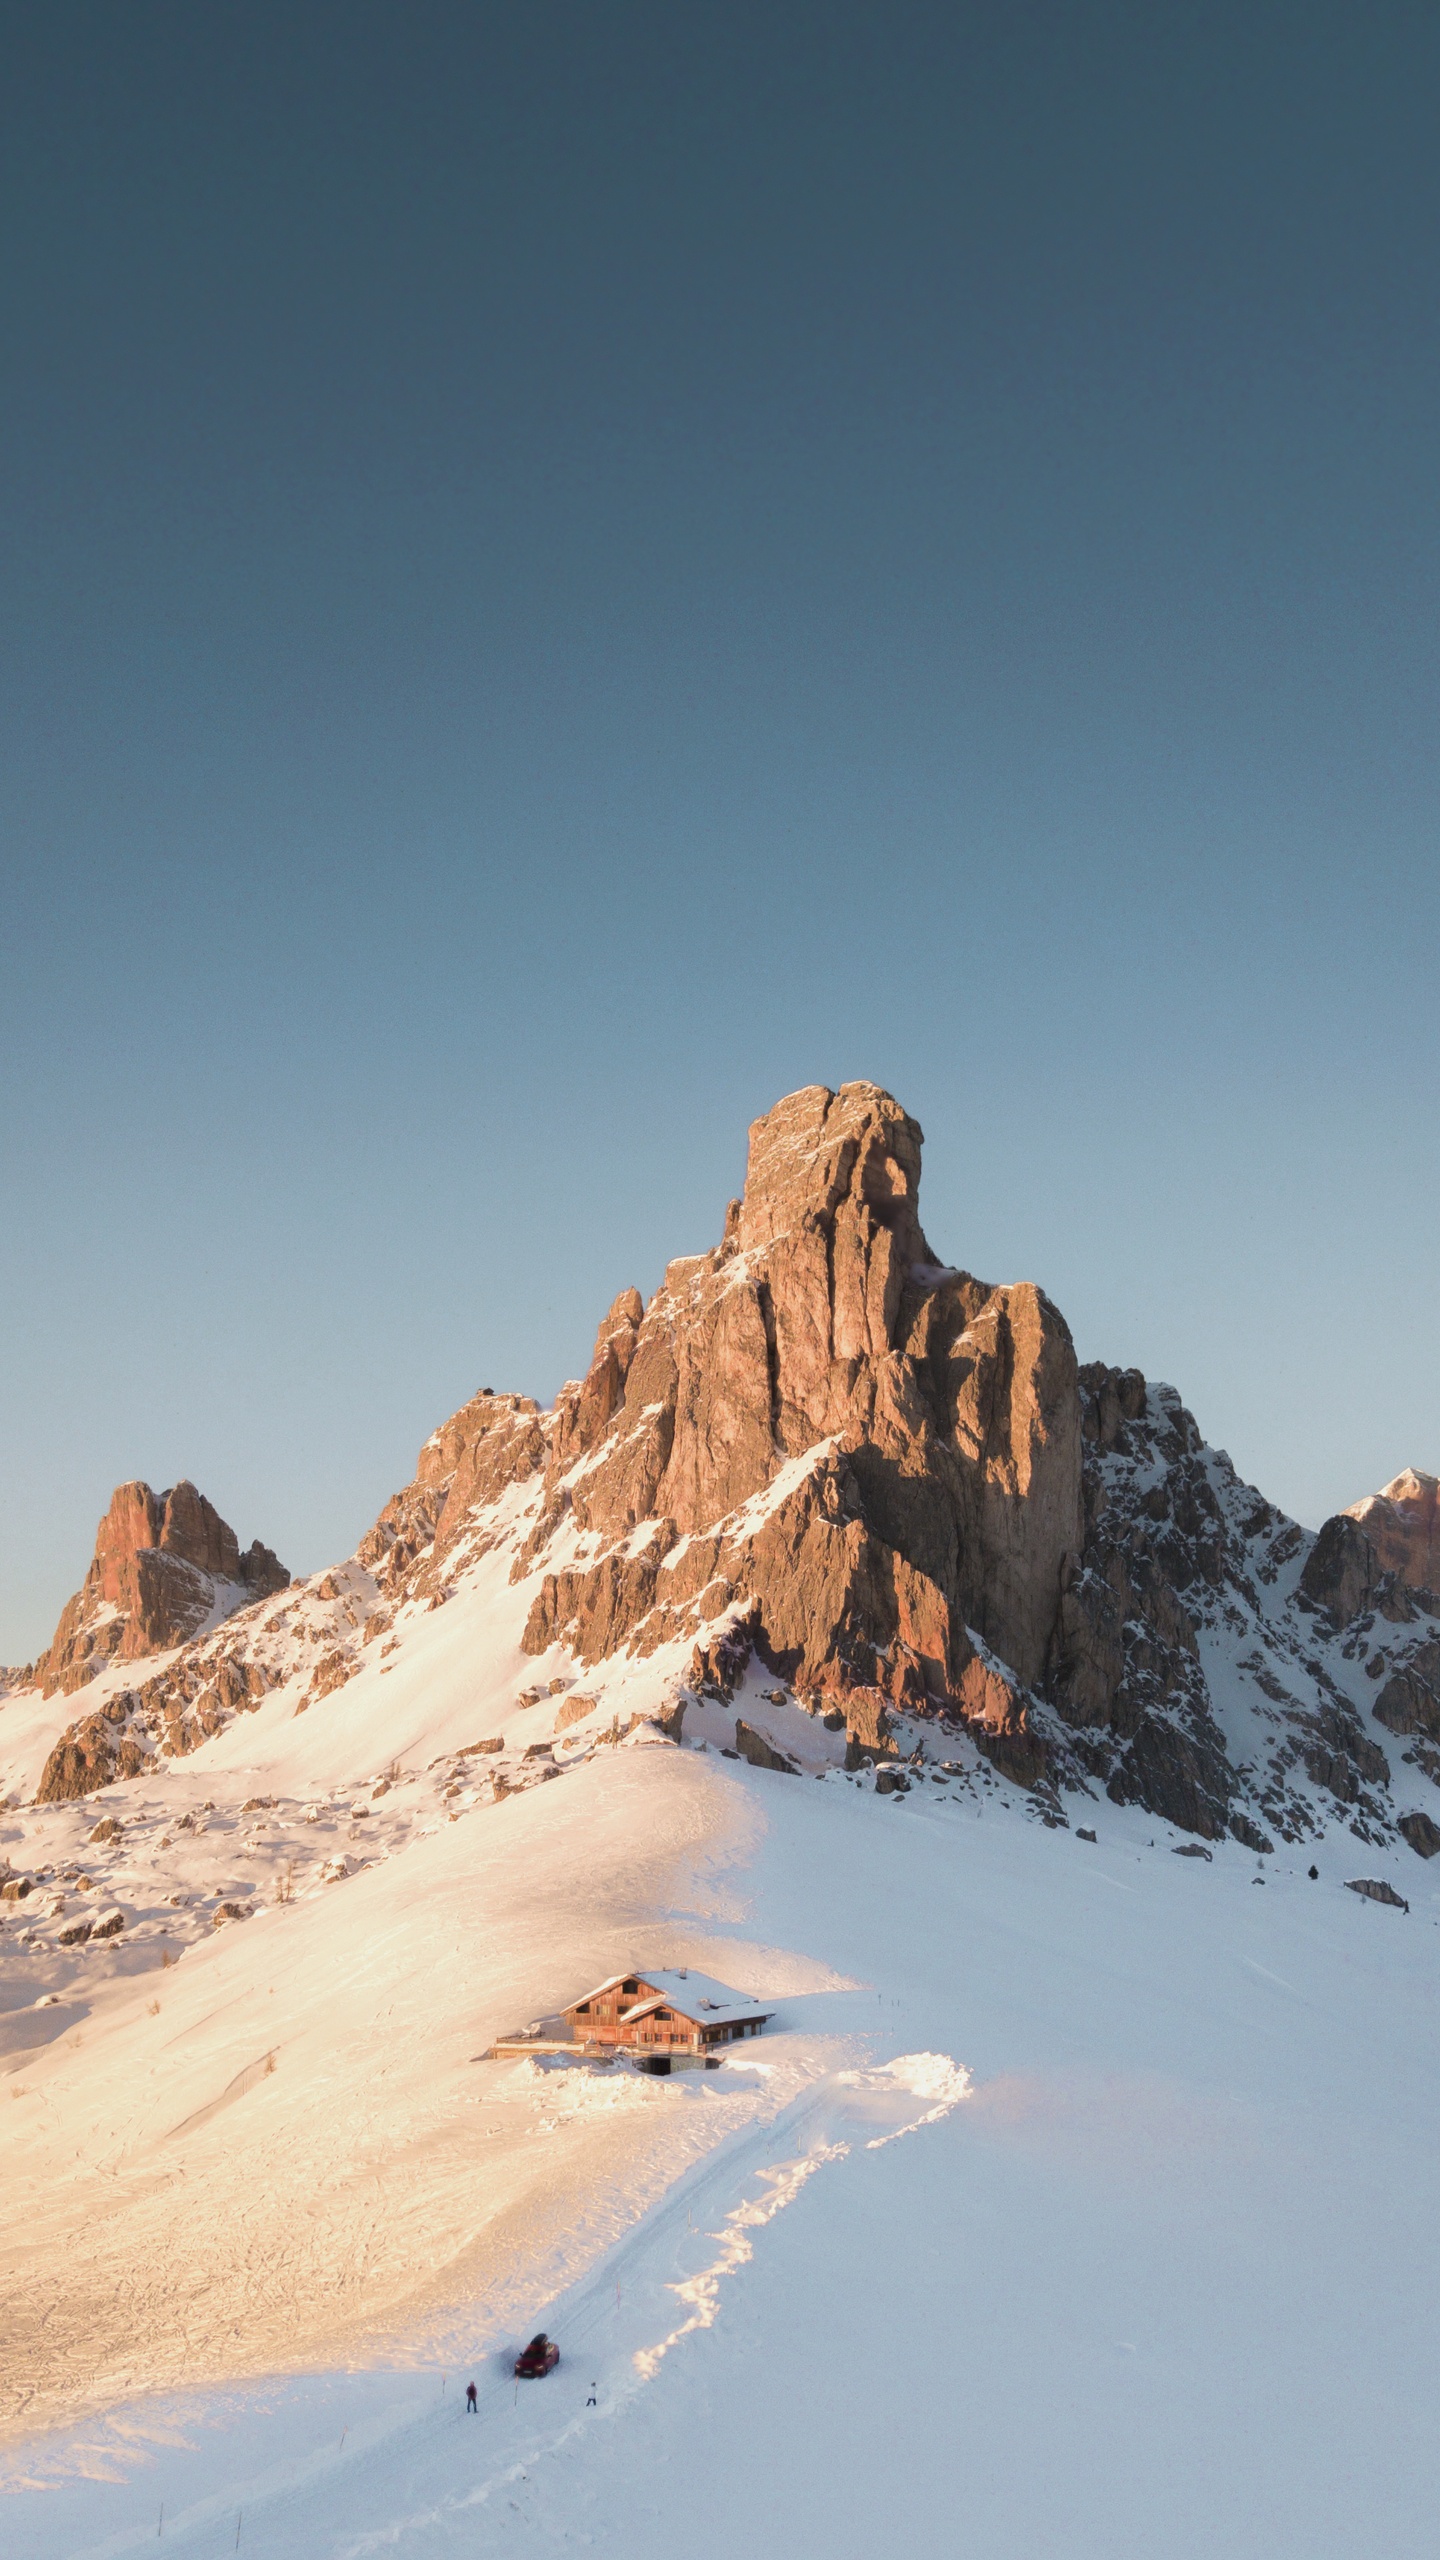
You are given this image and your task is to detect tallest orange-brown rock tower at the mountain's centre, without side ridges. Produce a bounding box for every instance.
[515,1085,1081,1723]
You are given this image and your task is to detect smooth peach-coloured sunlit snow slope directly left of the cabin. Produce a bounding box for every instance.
[0,1751,825,2427]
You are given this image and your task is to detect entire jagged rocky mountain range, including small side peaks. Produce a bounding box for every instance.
[28,1083,1440,1856]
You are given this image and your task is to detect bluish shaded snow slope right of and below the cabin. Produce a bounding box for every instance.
[0,1748,1440,2560]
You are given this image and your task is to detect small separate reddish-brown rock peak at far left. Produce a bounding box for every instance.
[36,1482,290,1697]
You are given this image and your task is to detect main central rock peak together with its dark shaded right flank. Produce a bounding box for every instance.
[489,1085,1440,1856]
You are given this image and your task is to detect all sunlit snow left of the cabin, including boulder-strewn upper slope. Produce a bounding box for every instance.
[0,1521,835,2424]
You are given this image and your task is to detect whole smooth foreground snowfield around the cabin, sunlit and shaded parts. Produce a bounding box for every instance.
[0,1746,1440,2560]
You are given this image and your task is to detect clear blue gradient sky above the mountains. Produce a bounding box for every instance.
[0,0,1440,1661]
